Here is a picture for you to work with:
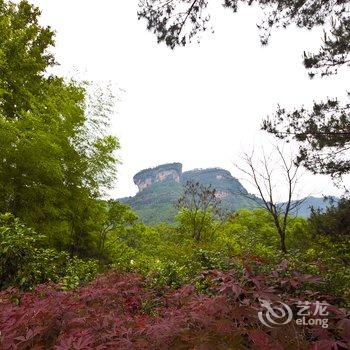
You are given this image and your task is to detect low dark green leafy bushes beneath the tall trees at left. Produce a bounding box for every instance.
[0,214,98,290]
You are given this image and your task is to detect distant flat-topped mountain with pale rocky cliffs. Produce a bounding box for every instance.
[119,163,336,225]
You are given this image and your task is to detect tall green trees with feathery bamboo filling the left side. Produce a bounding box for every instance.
[0,1,119,254]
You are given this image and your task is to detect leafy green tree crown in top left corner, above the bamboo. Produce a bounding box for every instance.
[0,0,55,120]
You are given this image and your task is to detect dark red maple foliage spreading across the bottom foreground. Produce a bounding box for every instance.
[0,267,350,350]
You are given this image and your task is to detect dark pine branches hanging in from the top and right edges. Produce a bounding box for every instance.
[138,0,350,179]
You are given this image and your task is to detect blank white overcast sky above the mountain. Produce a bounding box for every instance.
[32,0,350,197]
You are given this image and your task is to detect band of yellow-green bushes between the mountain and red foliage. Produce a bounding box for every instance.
[107,210,350,306]
